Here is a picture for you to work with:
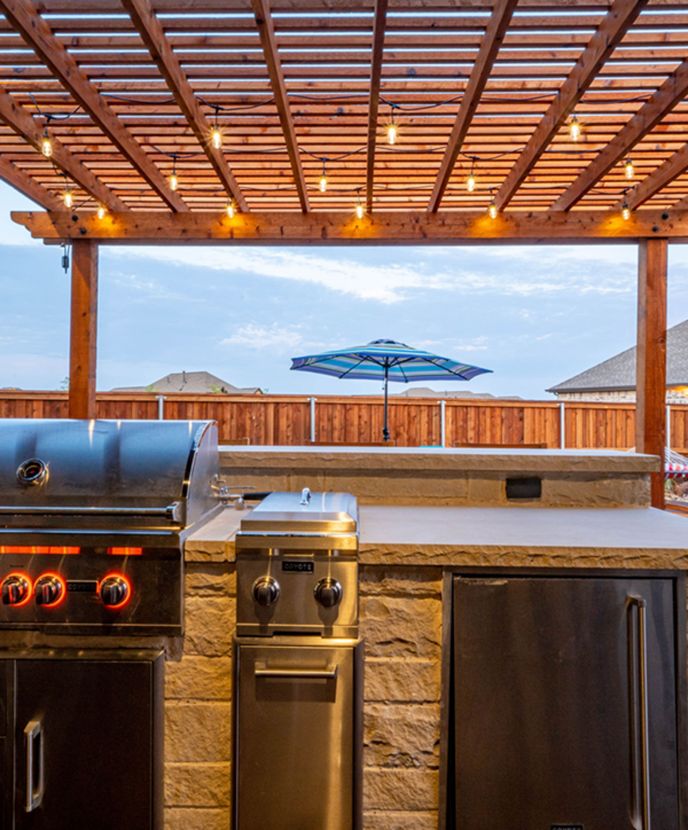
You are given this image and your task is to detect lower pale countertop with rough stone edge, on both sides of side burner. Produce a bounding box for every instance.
[185,505,688,569]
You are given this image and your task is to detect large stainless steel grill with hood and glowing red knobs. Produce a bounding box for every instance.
[0,419,220,634]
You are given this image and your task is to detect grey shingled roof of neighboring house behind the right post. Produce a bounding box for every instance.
[547,320,688,393]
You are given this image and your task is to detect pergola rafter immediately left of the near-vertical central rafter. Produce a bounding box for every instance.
[251,0,310,213]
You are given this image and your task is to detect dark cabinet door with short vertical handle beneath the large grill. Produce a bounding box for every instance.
[14,659,162,830]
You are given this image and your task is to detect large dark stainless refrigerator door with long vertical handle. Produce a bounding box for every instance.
[454,577,679,830]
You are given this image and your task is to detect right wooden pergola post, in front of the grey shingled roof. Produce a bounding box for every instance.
[635,239,667,509]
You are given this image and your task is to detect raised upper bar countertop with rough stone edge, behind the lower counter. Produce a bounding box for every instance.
[220,445,660,474]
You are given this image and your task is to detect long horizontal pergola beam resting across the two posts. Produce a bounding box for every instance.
[12,210,688,245]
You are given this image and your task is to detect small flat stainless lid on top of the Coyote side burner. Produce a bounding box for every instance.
[240,487,358,535]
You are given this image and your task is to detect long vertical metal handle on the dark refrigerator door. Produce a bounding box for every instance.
[628,595,652,830]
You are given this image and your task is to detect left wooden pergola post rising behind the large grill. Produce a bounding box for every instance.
[69,239,98,418]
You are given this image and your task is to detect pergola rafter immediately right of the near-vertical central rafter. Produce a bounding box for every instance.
[428,0,518,213]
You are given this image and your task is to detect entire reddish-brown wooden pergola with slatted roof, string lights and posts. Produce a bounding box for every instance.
[0,0,688,505]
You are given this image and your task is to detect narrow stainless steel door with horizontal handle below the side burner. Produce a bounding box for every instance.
[235,645,356,830]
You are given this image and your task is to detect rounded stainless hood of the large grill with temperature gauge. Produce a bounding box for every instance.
[0,419,218,528]
